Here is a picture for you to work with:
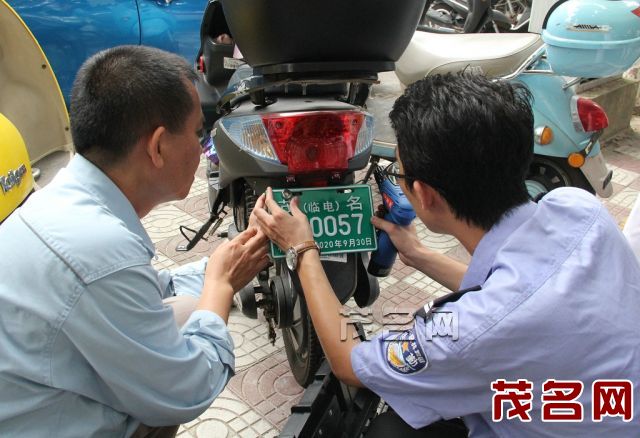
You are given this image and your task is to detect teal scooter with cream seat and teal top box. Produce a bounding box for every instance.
[373,0,640,198]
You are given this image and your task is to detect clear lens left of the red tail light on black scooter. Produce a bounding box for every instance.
[220,116,280,163]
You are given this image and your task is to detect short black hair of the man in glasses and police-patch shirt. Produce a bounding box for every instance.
[389,73,533,230]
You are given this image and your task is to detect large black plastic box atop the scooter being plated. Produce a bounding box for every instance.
[221,0,425,71]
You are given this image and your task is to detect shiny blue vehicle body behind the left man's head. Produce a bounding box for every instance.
[8,0,208,105]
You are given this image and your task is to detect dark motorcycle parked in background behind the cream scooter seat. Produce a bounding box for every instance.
[418,0,531,33]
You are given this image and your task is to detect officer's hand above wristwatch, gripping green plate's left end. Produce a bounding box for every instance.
[252,187,313,251]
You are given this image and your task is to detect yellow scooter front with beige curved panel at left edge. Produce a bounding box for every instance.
[0,0,72,222]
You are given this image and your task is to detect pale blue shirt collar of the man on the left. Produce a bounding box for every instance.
[66,154,156,257]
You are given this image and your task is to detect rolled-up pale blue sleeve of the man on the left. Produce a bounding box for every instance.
[52,266,234,426]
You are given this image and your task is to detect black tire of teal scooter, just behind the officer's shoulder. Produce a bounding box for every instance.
[526,156,595,200]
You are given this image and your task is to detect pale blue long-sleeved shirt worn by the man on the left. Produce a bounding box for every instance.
[0,155,234,437]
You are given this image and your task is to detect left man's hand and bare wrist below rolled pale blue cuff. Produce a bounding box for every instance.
[198,227,269,322]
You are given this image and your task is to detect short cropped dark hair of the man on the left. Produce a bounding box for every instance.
[70,46,196,167]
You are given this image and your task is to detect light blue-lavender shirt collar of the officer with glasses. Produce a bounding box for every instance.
[460,201,537,290]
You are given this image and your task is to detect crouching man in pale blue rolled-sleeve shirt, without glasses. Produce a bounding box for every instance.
[0,46,268,437]
